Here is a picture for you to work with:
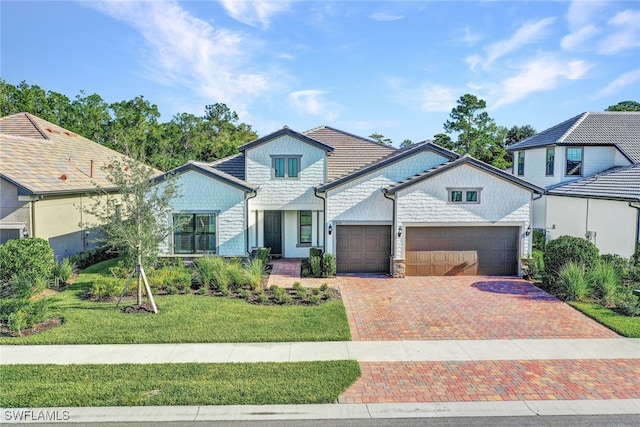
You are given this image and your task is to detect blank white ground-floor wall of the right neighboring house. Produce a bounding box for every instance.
[547,196,638,258]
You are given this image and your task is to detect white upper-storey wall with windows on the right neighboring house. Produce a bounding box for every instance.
[513,146,630,187]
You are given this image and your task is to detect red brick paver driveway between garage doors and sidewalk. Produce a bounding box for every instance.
[338,276,618,340]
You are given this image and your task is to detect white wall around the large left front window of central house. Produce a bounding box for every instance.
[161,171,247,256]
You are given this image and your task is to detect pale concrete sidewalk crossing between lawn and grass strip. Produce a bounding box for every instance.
[0,338,640,365]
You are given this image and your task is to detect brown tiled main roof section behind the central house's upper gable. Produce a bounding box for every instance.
[304,126,396,181]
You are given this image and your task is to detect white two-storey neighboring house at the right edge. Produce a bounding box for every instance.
[508,112,640,258]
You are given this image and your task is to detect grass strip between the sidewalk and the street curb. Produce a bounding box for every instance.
[0,360,360,408]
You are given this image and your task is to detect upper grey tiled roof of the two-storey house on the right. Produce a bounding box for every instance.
[507,111,640,163]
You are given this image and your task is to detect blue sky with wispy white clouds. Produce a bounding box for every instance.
[0,0,640,146]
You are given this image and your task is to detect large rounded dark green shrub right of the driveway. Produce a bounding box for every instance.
[543,236,599,282]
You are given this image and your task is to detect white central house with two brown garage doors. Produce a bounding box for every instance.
[159,126,543,277]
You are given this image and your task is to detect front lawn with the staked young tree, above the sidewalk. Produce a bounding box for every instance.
[0,260,351,345]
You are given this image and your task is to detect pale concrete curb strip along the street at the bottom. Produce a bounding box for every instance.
[0,399,640,424]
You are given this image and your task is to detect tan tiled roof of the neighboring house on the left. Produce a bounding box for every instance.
[0,113,159,195]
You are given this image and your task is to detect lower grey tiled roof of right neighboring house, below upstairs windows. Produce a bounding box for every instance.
[547,163,640,201]
